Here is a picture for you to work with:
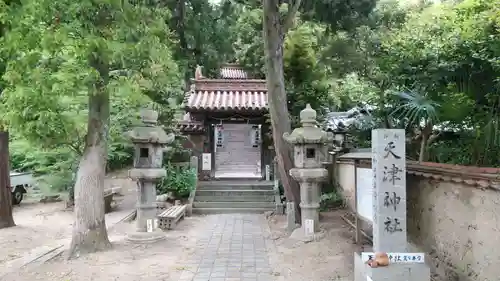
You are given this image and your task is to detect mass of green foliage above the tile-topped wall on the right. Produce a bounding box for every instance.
[325,0,500,166]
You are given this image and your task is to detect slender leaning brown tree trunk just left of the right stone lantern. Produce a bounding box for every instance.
[264,0,300,223]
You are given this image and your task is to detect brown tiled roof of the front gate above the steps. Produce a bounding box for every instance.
[184,79,268,111]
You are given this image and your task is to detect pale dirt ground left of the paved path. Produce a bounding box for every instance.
[0,168,211,281]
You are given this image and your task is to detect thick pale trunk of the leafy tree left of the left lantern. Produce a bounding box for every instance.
[69,88,111,258]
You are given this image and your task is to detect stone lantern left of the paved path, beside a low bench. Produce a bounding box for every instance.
[128,109,175,242]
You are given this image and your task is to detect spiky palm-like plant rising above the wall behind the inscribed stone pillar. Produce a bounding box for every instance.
[391,91,439,162]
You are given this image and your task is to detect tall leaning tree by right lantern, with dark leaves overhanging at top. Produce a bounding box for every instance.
[262,0,375,223]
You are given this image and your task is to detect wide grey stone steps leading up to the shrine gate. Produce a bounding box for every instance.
[193,179,275,214]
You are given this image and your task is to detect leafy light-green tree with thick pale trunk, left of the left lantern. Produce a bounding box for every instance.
[4,0,181,257]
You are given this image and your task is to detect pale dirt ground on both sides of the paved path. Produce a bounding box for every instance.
[0,168,362,281]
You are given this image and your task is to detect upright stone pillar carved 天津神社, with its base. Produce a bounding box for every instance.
[354,129,430,281]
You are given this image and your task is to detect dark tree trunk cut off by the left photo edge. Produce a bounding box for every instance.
[0,131,16,229]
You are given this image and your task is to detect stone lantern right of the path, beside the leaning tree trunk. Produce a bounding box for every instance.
[283,104,333,232]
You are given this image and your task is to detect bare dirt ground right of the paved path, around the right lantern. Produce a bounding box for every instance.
[269,210,357,281]
